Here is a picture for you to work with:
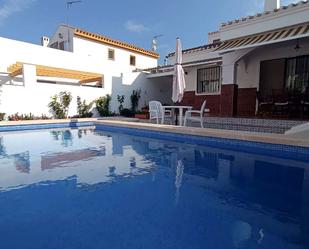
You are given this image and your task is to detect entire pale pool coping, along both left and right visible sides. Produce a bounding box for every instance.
[0,118,309,148]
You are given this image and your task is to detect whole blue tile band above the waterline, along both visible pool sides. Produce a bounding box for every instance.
[0,122,309,162]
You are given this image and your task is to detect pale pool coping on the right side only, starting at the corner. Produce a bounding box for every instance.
[94,120,309,148]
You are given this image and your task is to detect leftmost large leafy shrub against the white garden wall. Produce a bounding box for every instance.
[48,92,72,119]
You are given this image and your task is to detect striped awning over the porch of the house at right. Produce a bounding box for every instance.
[215,23,309,53]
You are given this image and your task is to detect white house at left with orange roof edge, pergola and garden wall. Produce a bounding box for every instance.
[0,25,170,115]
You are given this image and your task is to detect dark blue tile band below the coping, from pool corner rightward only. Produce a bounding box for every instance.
[95,122,309,161]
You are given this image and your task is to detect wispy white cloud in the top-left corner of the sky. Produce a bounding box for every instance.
[0,0,37,24]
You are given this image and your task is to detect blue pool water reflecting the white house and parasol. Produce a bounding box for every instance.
[0,128,309,249]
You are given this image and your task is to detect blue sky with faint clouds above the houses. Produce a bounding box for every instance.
[0,0,297,61]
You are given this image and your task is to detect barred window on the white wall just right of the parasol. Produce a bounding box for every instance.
[196,66,222,94]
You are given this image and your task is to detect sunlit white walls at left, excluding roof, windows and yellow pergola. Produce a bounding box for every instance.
[0,33,158,115]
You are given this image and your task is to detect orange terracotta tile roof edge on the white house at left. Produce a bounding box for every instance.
[74,28,160,59]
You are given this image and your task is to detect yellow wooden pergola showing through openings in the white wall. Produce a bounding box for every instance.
[7,62,103,84]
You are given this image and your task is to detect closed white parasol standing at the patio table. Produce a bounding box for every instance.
[172,38,186,103]
